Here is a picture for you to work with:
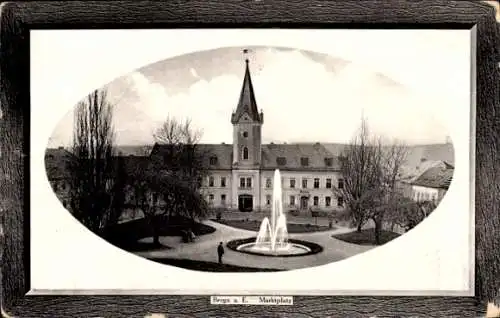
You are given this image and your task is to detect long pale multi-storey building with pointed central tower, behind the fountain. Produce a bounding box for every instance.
[152,60,344,211]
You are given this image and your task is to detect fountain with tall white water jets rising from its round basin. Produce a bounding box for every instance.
[236,169,311,256]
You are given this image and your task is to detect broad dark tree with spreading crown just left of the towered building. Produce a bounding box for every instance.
[122,117,208,245]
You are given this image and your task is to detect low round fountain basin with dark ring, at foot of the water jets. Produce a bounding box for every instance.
[227,237,323,257]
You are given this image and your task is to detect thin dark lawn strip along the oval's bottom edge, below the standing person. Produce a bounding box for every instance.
[148,258,281,272]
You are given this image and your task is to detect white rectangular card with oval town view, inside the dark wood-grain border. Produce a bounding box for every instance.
[30,29,475,301]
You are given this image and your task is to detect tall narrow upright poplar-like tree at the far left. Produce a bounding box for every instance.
[68,90,114,232]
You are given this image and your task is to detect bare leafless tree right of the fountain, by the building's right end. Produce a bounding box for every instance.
[334,119,408,244]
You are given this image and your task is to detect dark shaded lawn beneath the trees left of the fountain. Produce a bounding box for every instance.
[103,217,215,252]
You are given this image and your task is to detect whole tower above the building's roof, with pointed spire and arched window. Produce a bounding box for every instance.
[231,50,264,169]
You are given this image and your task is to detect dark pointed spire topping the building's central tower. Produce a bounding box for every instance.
[231,49,262,124]
